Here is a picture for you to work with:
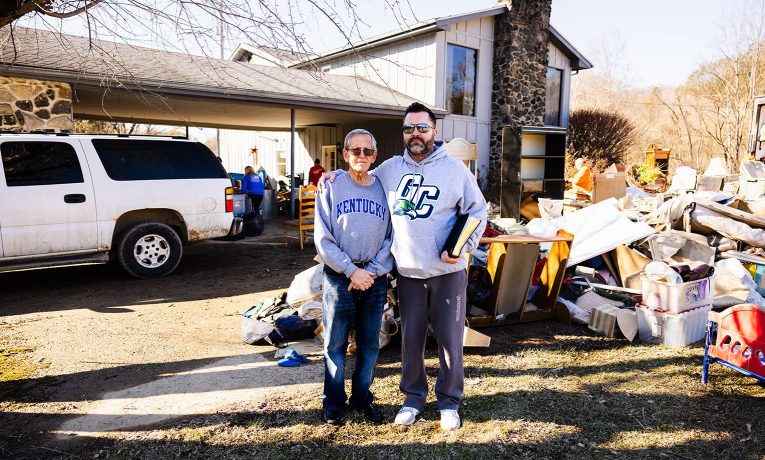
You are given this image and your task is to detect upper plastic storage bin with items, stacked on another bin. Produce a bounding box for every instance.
[642,276,714,313]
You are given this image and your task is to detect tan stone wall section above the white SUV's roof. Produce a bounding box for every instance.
[0,77,74,132]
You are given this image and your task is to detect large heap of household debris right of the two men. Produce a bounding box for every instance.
[468,159,765,347]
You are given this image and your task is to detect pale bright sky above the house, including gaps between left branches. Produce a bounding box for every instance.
[25,0,765,87]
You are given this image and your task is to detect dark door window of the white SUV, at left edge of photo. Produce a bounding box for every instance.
[0,142,84,187]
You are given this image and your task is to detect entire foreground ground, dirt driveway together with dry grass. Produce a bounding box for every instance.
[0,221,765,460]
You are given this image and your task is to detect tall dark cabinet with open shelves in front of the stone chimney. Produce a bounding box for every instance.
[500,126,566,219]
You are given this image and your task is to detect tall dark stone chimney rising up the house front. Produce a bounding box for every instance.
[486,0,552,199]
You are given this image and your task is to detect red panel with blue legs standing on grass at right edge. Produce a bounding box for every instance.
[701,304,765,383]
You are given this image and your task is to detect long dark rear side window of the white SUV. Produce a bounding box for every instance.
[93,139,228,181]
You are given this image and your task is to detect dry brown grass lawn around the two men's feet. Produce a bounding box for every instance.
[86,322,765,460]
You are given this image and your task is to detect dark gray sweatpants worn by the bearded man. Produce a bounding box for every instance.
[397,270,467,411]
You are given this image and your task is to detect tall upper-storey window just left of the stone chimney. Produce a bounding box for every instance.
[446,44,478,117]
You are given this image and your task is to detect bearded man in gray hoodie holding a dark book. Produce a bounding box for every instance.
[320,102,486,430]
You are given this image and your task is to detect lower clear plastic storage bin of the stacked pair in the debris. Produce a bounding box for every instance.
[635,304,712,348]
